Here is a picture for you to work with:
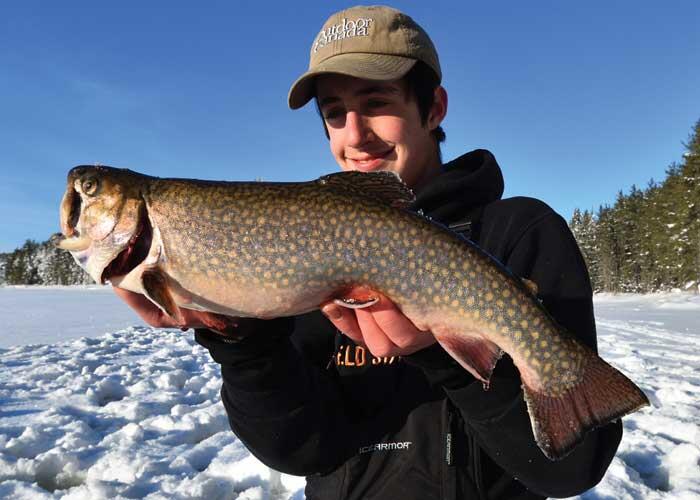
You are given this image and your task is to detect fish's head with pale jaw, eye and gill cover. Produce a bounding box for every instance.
[52,165,151,283]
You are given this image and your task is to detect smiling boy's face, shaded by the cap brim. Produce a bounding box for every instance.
[316,74,444,187]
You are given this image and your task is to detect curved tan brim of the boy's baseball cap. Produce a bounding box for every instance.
[288,53,416,109]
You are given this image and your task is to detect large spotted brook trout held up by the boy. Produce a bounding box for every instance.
[54,166,649,460]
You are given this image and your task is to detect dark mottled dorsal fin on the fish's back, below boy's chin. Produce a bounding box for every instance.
[316,171,416,208]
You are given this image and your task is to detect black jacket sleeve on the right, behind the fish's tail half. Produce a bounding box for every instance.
[407,211,622,497]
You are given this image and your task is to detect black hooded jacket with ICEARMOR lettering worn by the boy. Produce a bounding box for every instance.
[196,150,622,500]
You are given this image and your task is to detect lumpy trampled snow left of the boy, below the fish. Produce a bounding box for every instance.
[0,327,304,500]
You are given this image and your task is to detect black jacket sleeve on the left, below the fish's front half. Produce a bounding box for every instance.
[196,314,352,476]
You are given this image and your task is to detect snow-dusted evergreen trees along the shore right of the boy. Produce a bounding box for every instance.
[569,120,700,292]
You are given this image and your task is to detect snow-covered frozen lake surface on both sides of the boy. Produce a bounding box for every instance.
[0,288,700,500]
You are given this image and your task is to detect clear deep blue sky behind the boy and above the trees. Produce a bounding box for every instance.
[0,0,700,251]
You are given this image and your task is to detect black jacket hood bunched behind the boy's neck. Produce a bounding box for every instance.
[412,149,504,223]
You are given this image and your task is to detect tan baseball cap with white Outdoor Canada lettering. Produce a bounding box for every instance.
[288,5,442,109]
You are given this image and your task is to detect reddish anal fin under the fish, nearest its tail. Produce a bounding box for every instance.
[433,332,503,389]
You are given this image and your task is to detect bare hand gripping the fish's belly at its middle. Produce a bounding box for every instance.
[321,295,437,357]
